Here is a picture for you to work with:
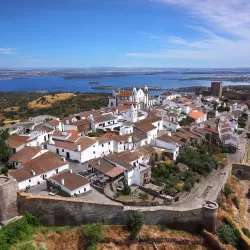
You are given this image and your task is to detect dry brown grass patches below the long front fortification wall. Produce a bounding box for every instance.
[30,226,207,250]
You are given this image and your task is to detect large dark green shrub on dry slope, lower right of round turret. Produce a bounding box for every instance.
[217,223,241,246]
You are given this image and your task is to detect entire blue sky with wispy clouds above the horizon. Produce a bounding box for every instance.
[0,0,250,68]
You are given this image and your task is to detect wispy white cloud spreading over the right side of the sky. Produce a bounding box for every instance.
[126,0,250,67]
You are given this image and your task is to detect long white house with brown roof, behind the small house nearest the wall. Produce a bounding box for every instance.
[9,151,69,190]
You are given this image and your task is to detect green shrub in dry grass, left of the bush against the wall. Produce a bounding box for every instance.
[83,222,103,247]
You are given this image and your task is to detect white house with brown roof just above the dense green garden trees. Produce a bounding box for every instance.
[155,134,180,161]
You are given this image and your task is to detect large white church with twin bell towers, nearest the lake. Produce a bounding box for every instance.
[109,86,153,109]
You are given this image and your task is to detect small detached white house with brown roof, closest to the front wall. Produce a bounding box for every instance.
[50,171,91,196]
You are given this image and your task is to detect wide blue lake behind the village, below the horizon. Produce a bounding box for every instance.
[0,74,243,95]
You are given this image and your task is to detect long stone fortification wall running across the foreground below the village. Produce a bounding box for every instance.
[18,194,217,231]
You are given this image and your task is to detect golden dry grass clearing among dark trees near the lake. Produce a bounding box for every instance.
[29,93,75,109]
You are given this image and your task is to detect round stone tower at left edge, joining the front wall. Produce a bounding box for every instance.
[0,175,18,224]
